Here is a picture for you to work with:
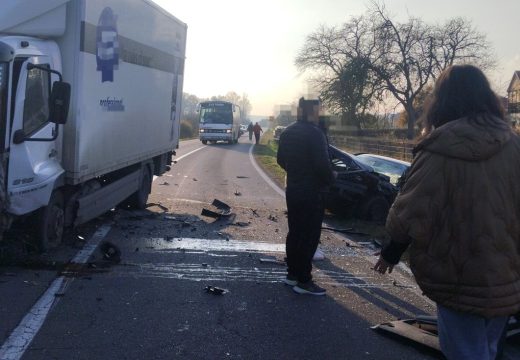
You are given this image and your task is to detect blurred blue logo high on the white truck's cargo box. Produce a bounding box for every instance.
[96,7,119,82]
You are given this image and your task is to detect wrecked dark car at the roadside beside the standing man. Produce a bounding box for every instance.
[325,146,404,222]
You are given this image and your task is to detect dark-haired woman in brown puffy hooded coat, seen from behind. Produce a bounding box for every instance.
[374,65,520,360]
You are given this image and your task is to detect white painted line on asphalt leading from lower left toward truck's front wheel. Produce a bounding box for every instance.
[0,226,110,360]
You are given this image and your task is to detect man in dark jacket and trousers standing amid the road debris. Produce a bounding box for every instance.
[277,98,335,295]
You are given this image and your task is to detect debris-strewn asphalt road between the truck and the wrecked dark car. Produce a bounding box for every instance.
[0,137,516,360]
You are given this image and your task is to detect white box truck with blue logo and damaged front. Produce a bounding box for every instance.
[0,0,187,251]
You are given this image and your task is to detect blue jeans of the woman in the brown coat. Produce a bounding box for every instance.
[437,304,509,360]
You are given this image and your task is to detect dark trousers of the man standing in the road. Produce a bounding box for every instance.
[286,191,324,283]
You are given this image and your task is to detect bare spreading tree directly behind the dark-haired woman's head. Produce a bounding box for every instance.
[369,1,493,139]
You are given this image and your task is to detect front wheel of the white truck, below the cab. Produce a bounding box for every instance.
[35,191,65,253]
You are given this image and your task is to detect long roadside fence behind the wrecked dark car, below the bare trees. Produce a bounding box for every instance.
[329,135,415,162]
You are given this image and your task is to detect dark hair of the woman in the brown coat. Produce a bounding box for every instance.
[423,65,505,133]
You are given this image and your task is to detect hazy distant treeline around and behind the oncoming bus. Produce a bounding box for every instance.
[180,91,252,139]
